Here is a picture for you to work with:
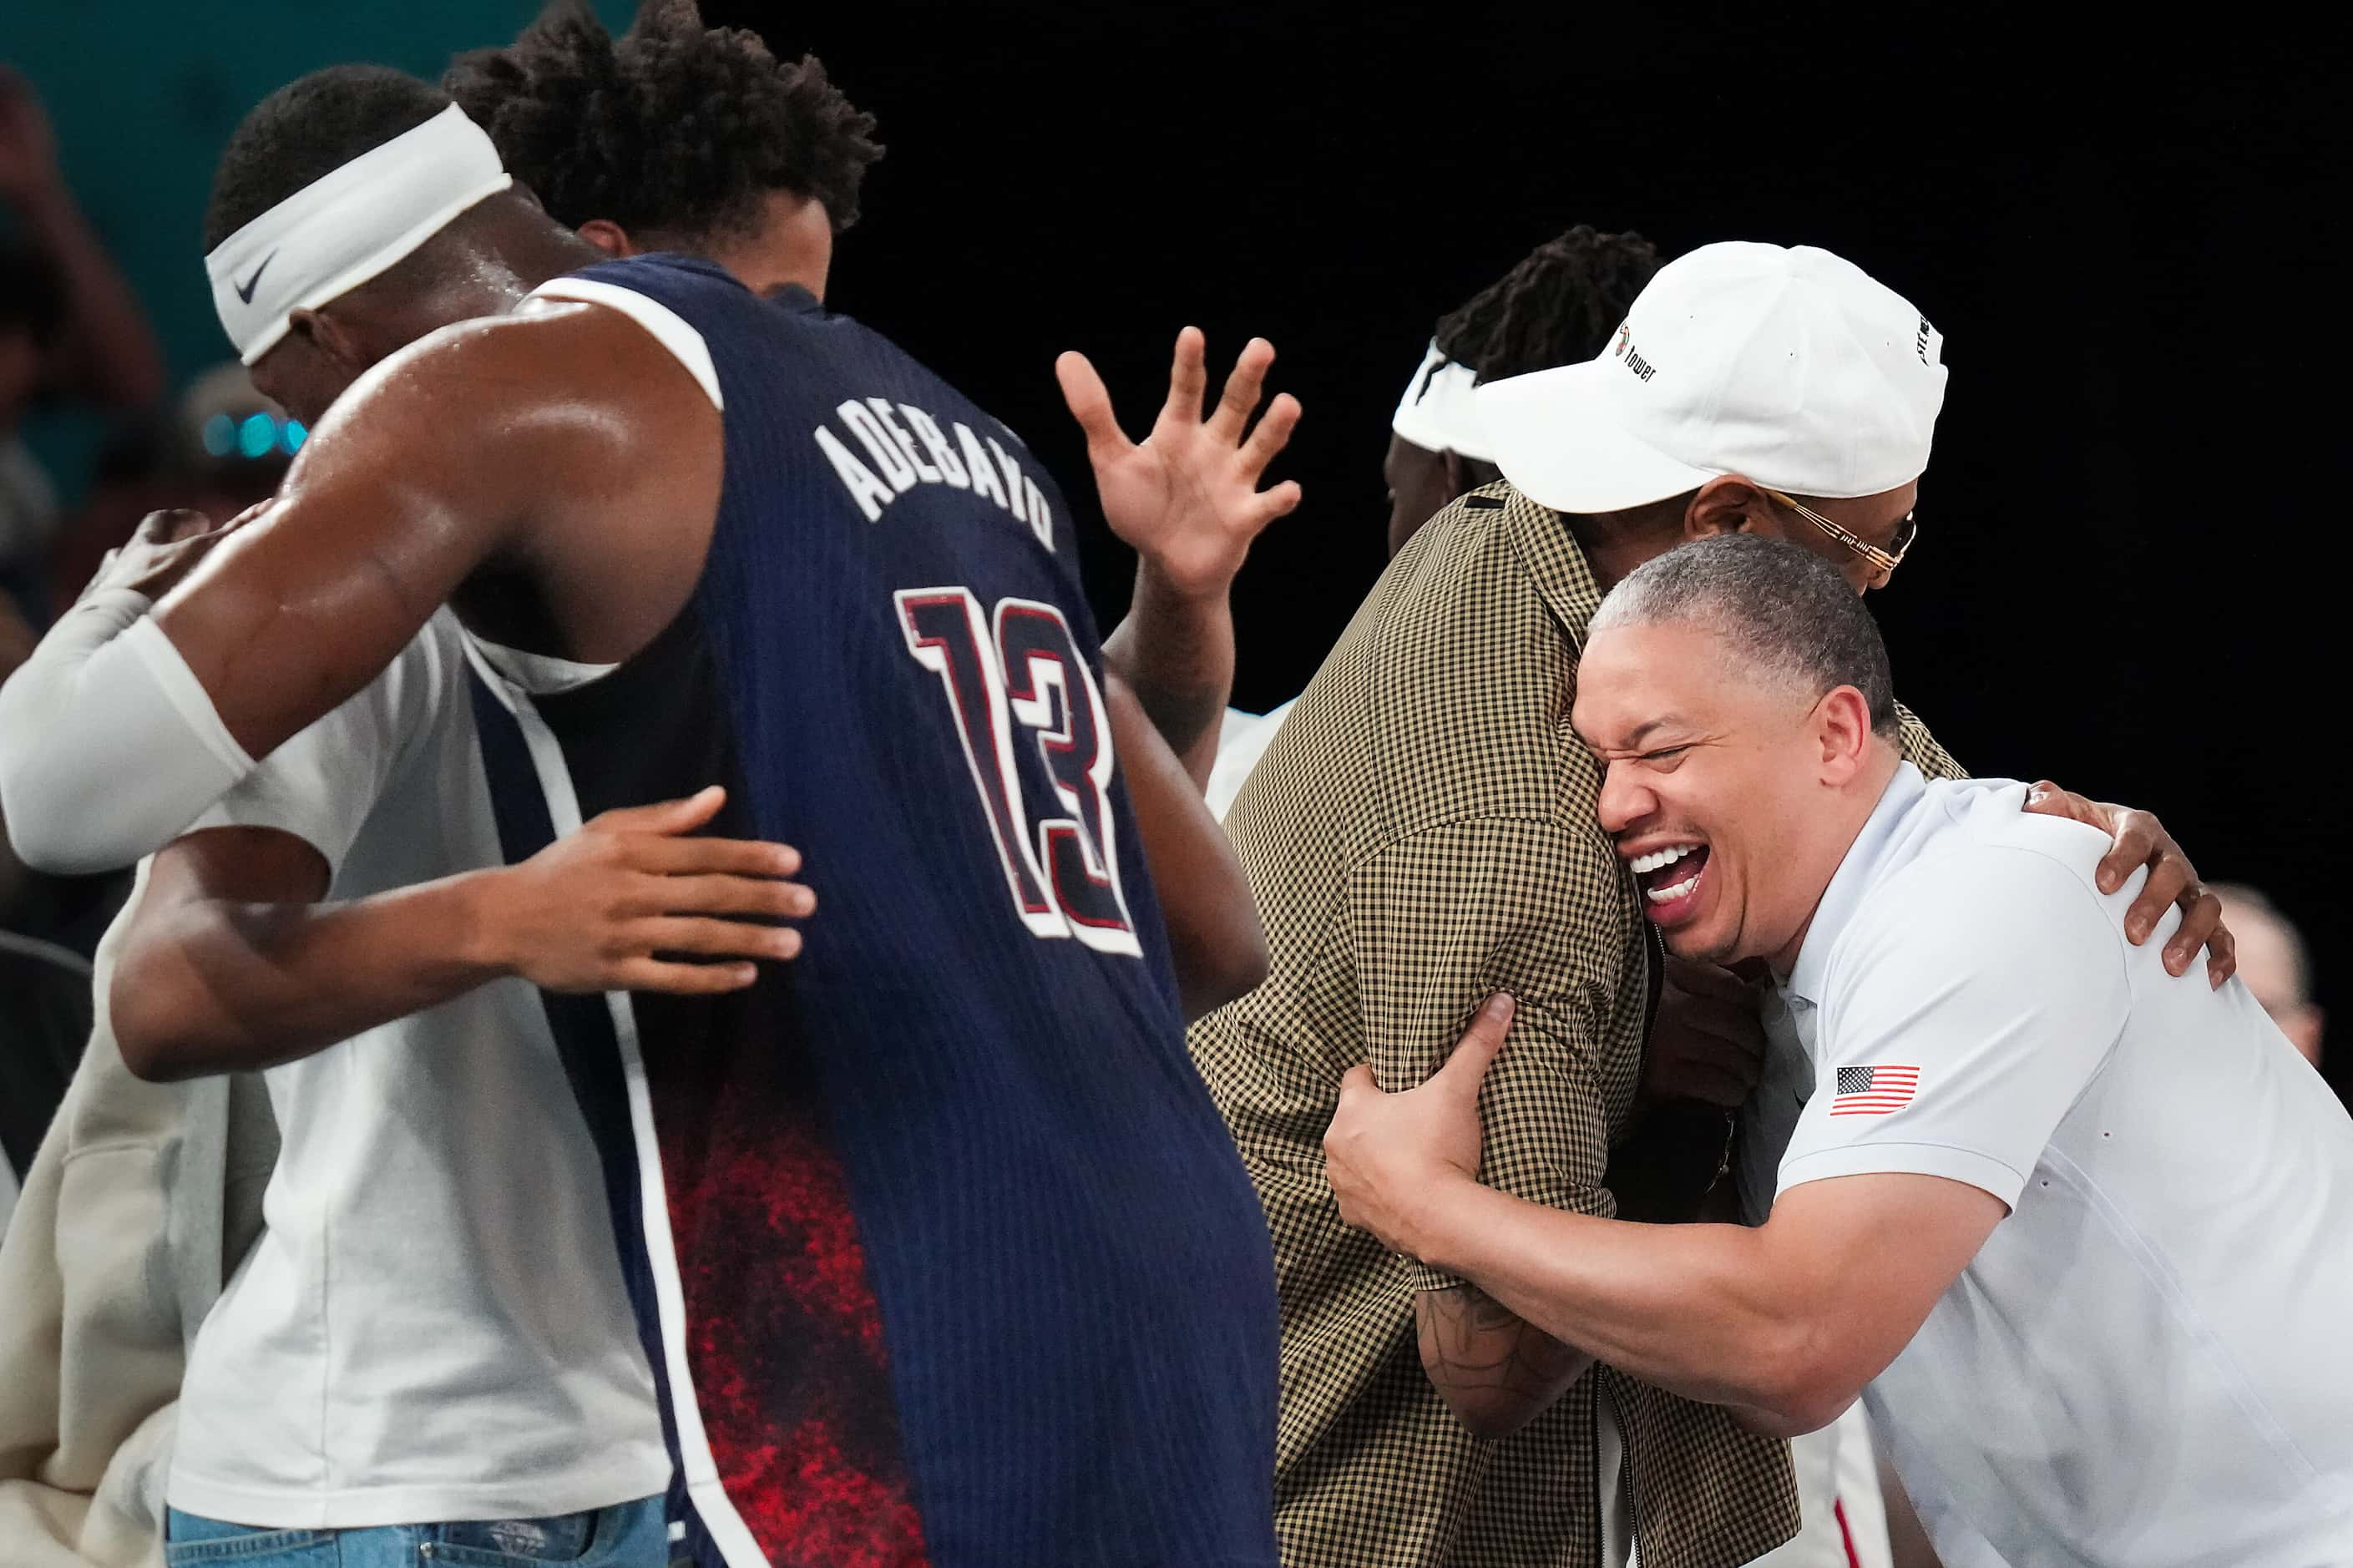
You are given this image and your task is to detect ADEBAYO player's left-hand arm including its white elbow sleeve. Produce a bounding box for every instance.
[0,306,717,869]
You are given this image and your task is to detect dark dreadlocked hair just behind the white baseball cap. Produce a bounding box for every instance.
[1438,224,1659,382]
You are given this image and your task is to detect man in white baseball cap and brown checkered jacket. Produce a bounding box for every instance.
[1193,245,2229,1568]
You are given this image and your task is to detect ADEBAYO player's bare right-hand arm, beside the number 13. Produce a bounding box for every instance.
[1104,671,1266,1022]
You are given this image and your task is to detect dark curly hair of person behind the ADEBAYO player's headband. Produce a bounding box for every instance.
[443,0,883,238]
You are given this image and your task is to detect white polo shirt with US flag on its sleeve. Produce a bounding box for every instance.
[1767,765,2353,1568]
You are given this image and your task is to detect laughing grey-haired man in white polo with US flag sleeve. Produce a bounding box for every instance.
[1327,537,2353,1568]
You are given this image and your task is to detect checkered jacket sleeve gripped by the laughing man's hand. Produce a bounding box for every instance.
[1349,817,1645,1290]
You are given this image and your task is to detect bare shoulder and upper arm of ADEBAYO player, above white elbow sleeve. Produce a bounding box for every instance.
[155,306,720,758]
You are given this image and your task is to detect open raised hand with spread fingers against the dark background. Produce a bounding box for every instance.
[1054,327,1299,594]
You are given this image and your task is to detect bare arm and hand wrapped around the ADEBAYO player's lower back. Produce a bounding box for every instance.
[109,789,814,1080]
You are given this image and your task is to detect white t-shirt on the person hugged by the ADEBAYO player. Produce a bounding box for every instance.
[167,609,670,1528]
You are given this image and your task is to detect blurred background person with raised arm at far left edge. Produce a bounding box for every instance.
[0,66,164,621]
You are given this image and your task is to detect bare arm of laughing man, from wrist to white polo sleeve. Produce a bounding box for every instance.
[1403,1158,2007,1436]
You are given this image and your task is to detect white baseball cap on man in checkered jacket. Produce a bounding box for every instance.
[1475,240,1944,513]
